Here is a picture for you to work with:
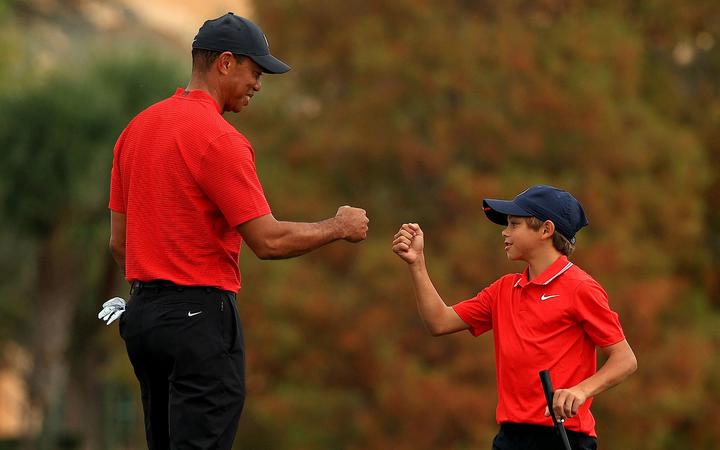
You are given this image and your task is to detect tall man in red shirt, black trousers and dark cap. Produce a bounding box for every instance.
[109,13,368,450]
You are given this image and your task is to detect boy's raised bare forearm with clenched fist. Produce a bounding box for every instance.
[393,223,469,336]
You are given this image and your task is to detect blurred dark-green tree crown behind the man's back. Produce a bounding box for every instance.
[0,57,183,236]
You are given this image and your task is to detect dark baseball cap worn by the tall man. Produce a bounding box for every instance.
[192,12,290,73]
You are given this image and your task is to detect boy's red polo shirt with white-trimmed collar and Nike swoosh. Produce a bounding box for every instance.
[453,256,625,436]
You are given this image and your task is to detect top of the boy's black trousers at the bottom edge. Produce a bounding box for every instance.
[493,423,597,450]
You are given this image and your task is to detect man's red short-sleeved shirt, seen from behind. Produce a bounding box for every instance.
[109,89,270,291]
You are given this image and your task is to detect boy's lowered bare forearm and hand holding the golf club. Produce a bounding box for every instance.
[545,339,637,419]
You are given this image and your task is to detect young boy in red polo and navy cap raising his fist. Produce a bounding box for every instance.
[392,185,637,449]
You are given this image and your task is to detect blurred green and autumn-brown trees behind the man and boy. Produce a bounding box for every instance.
[0,0,720,450]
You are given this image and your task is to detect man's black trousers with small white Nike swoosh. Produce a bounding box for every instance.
[120,282,245,450]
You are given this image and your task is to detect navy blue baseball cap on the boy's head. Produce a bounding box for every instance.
[483,185,588,244]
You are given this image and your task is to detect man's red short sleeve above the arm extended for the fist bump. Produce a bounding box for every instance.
[198,133,270,227]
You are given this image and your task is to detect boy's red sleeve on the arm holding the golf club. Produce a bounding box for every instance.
[575,281,625,347]
